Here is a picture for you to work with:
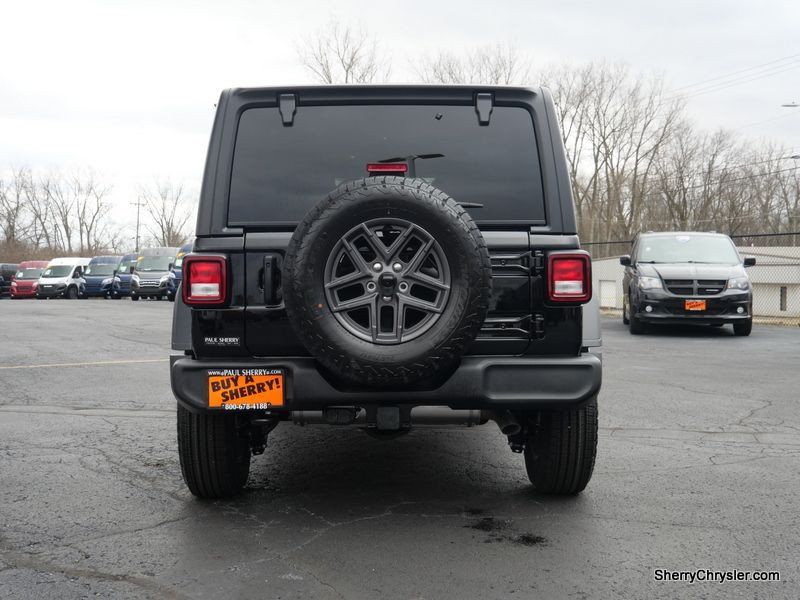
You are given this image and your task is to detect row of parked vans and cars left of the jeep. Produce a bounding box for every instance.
[0,243,192,301]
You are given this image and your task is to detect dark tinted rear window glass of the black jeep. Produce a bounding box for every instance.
[228,105,545,226]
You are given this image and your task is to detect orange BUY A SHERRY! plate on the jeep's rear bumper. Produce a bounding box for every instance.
[208,369,284,409]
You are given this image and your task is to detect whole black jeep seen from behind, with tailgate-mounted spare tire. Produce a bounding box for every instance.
[171,86,601,498]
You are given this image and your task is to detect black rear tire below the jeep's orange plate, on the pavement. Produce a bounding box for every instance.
[178,405,250,498]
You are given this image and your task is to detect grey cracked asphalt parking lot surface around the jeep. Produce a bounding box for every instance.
[0,300,800,599]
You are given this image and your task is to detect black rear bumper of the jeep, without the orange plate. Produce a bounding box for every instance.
[170,353,602,411]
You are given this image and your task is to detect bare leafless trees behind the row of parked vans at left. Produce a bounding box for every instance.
[0,167,196,262]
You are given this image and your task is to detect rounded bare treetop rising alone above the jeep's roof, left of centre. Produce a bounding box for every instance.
[296,20,391,84]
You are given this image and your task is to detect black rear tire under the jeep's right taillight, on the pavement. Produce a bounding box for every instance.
[525,397,597,495]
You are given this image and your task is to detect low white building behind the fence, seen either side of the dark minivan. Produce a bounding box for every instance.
[592,246,800,318]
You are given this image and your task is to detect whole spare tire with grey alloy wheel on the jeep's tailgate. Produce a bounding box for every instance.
[282,177,491,387]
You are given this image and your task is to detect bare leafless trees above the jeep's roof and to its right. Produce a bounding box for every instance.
[297,24,800,253]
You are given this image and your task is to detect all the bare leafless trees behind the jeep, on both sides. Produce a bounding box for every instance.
[0,22,800,261]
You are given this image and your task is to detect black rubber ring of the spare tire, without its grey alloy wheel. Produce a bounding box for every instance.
[283,177,491,386]
